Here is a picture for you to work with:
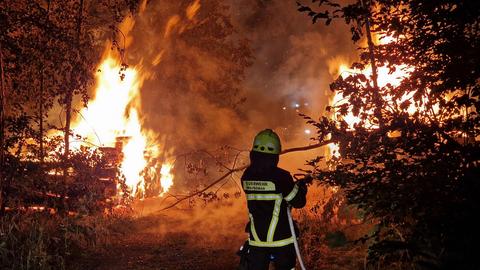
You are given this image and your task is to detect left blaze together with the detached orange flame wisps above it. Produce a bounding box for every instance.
[72,0,206,197]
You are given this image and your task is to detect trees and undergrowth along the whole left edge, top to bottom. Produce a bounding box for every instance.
[0,0,139,269]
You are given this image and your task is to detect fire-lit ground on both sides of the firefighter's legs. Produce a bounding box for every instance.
[76,195,365,270]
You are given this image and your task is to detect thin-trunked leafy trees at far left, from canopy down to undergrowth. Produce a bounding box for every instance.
[0,0,139,213]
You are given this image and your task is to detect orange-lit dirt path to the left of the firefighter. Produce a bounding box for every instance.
[79,197,246,270]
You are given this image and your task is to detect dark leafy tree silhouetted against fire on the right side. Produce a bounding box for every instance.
[298,0,480,269]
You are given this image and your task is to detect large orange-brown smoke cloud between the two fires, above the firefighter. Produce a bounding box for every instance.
[117,0,354,157]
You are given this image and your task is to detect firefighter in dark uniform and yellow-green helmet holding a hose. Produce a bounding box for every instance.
[240,129,307,270]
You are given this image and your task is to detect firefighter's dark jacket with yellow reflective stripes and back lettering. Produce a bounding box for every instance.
[242,153,306,247]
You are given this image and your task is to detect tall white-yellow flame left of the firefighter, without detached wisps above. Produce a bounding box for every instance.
[72,54,173,196]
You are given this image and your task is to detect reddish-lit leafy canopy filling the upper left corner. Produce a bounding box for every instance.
[0,0,134,117]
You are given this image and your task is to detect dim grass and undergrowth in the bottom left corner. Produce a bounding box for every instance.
[0,211,135,270]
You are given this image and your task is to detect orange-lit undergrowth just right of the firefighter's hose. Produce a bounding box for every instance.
[295,187,373,269]
